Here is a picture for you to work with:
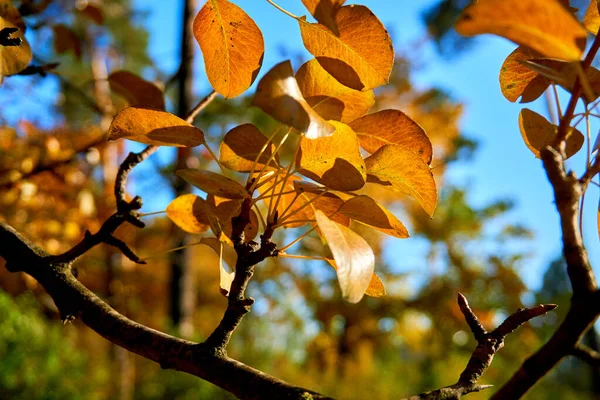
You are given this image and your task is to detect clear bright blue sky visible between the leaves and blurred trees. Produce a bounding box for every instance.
[135,0,600,288]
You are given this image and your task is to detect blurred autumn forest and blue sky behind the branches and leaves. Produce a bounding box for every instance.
[0,0,600,400]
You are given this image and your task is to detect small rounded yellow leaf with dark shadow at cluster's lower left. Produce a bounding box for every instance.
[166,194,210,233]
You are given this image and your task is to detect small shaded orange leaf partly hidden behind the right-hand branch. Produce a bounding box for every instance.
[519,108,584,158]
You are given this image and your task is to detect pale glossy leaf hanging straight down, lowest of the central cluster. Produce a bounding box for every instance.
[315,211,375,303]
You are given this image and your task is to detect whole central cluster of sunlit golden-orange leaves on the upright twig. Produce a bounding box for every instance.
[109,0,437,302]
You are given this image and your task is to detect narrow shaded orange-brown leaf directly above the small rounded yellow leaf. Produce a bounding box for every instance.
[177,168,250,199]
